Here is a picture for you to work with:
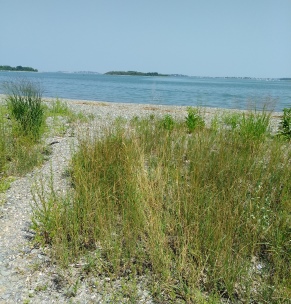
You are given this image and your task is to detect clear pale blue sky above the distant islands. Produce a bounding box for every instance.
[0,0,291,78]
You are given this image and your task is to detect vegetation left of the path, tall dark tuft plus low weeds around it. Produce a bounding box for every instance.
[0,80,89,192]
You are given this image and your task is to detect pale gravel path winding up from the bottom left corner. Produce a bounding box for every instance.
[0,113,153,304]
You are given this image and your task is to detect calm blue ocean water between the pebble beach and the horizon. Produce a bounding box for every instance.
[0,72,291,111]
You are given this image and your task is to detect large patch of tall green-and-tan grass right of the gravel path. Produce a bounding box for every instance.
[33,108,291,303]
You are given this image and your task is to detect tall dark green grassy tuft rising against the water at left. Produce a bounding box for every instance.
[4,80,44,140]
